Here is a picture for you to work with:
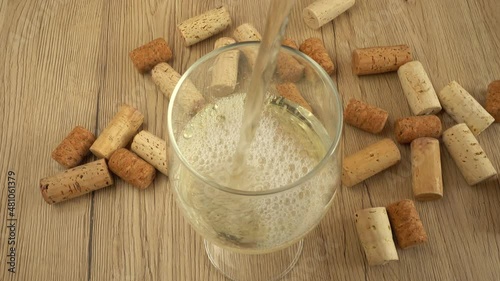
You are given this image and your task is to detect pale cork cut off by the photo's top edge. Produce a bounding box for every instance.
[302,0,355,29]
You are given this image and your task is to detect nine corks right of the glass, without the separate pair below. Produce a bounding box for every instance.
[342,45,500,201]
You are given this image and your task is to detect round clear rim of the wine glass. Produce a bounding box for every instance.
[167,41,343,196]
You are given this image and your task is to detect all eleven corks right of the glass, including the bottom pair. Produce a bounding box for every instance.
[342,45,500,265]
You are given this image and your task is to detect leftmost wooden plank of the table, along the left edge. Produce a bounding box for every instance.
[0,0,101,281]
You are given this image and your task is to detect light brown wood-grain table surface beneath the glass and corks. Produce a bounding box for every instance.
[0,0,500,281]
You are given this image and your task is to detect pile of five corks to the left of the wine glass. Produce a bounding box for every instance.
[40,105,168,204]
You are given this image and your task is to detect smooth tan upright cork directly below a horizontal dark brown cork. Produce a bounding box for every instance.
[410,137,443,201]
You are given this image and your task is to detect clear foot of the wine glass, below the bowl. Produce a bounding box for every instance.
[204,240,304,281]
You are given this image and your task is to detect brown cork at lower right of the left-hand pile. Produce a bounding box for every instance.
[108,148,156,189]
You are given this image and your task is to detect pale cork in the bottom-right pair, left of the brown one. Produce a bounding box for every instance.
[355,207,399,266]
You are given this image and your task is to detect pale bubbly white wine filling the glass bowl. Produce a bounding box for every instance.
[172,94,338,253]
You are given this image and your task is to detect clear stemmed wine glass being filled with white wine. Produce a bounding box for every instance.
[167,42,342,281]
